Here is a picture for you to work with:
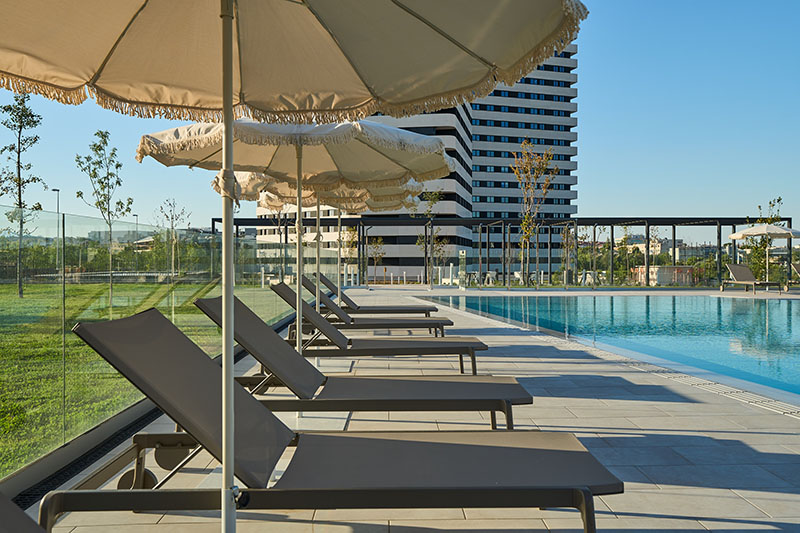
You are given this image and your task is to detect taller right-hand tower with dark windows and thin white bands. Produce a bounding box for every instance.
[471,45,578,278]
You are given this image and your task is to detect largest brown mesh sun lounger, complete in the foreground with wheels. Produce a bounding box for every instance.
[48,309,623,532]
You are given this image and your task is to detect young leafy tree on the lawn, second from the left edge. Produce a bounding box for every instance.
[75,130,133,318]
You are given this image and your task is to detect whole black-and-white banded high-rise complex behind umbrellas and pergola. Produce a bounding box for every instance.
[257,45,577,279]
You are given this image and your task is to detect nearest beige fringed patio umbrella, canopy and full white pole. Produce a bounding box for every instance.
[0,0,587,531]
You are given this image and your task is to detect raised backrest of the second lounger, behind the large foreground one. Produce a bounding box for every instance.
[194,296,325,399]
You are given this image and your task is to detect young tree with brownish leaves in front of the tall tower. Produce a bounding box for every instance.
[511,139,558,289]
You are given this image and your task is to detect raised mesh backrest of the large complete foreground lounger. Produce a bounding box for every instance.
[72,309,294,488]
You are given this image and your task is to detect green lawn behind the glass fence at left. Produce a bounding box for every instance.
[0,280,288,478]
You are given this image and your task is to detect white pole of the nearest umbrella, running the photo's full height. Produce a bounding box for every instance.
[220,0,237,533]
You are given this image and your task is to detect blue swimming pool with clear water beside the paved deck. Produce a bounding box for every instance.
[429,296,800,394]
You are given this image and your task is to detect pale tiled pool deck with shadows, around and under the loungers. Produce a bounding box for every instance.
[40,287,800,533]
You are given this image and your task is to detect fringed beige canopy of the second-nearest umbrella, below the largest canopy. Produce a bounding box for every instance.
[136,119,451,191]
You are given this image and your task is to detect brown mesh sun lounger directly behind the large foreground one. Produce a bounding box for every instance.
[194,297,533,429]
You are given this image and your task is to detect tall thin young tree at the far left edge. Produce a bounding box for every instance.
[0,94,47,298]
